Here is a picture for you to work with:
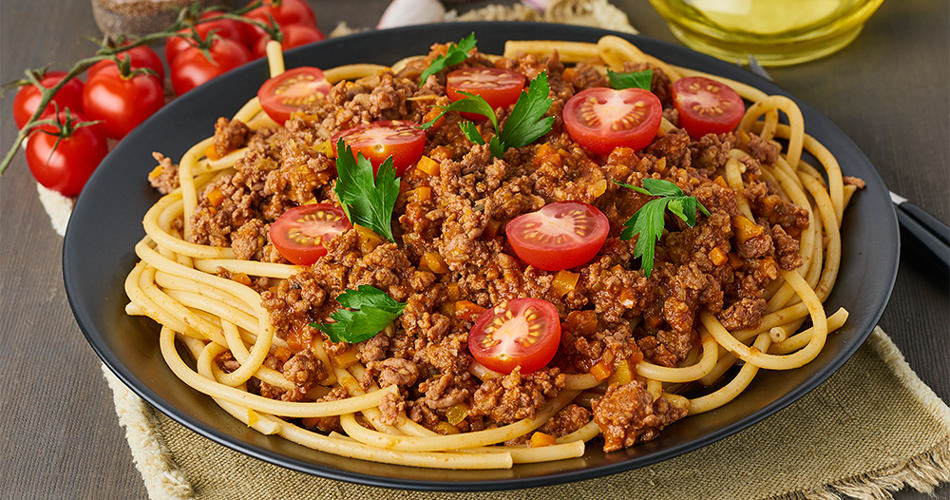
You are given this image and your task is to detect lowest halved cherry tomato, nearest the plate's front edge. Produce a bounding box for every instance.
[468,298,561,373]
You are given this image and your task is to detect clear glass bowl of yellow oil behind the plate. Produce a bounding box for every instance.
[650,0,882,66]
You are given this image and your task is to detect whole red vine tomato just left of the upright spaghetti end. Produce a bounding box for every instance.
[171,38,251,95]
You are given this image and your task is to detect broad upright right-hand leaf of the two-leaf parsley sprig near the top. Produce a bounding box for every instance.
[492,71,554,149]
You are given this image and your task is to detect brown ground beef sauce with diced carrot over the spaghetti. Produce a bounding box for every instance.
[165,45,820,451]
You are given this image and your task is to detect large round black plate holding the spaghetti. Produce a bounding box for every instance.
[63,23,899,491]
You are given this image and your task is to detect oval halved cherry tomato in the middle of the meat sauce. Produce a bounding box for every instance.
[505,201,610,271]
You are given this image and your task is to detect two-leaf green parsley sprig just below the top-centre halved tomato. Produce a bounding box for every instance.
[420,71,554,158]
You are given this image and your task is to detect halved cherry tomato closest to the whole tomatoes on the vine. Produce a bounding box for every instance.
[257,66,333,123]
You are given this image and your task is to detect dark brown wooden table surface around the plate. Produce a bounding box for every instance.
[0,0,950,499]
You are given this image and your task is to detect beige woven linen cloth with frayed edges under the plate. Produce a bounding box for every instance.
[37,0,950,500]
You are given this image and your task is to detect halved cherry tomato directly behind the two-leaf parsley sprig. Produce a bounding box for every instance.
[445,68,525,120]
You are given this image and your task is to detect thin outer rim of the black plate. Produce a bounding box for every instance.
[62,21,900,492]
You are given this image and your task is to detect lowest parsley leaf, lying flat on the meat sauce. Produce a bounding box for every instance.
[310,285,406,343]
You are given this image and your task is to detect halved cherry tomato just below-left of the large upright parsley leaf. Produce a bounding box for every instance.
[269,203,353,266]
